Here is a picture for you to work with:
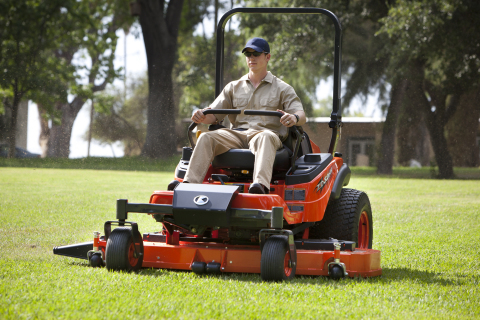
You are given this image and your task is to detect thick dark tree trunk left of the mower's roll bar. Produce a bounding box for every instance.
[140,0,183,158]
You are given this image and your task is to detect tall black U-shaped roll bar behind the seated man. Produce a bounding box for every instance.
[215,8,342,155]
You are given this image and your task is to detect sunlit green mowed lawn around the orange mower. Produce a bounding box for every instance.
[0,168,480,319]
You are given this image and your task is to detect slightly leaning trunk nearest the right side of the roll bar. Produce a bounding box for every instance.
[377,79,408,174]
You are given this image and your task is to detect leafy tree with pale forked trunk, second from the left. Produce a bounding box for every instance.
[39,0,132,158]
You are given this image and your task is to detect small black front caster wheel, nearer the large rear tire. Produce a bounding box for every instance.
[260,235,297,281]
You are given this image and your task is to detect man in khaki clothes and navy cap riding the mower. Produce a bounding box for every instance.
[184,38,306,194]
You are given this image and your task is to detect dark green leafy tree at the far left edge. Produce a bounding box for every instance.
[0,0,77,157]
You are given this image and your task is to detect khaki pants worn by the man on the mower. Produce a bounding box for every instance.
[184,129,282,187]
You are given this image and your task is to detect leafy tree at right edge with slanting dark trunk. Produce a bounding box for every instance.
[380,0,480,178]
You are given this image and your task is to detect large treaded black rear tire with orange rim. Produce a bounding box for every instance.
[309,188,373,249]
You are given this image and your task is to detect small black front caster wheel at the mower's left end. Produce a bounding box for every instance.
[105,227,143,272]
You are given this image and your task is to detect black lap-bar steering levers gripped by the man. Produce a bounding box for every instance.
[187,109,302,172]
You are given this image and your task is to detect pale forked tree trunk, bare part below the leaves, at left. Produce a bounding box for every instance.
[47,97,85,158]
